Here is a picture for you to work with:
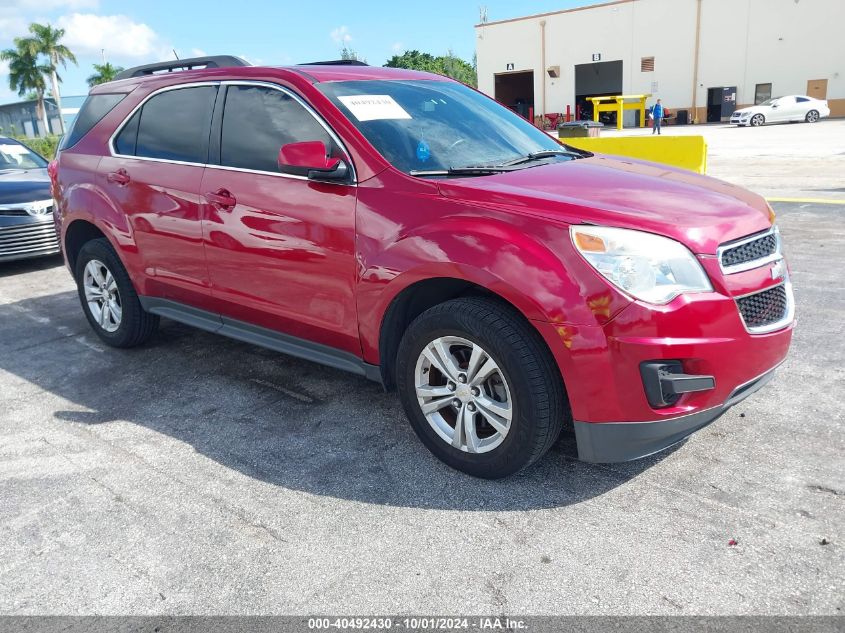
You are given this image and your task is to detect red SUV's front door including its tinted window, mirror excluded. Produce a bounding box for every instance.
[201,83,361,356]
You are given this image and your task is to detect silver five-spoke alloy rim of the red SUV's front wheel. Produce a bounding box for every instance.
[414,336,514,453]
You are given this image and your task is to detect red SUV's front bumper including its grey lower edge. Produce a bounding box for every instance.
[534,258,794,462]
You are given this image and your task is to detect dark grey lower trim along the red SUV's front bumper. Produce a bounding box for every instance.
[575,362,775,464]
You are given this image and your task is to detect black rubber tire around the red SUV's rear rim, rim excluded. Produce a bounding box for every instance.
[75,238,159,347]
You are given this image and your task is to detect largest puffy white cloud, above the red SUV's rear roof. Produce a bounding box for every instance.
[57,13,173,61]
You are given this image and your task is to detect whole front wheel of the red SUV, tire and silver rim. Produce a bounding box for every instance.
[396,297,568,479]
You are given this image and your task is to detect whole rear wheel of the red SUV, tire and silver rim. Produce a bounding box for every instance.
[76,238,159,347]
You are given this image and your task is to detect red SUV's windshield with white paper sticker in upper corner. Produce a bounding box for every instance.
[318,80,581,175]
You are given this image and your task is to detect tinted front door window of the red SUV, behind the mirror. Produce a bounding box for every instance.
[220,86,340,175]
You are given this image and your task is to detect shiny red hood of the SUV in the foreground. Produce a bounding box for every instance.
[439,155,770,255]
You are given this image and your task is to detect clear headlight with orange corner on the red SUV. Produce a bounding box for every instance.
[570,225,713,305]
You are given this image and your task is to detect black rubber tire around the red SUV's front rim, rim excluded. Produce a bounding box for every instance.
[396,297,570,479]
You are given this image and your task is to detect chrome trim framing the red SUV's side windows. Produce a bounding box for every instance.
[108,79,358,187]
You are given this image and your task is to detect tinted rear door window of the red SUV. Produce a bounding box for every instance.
[134,86,217,163]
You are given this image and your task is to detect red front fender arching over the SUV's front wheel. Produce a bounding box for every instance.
[358,213,629,363]
